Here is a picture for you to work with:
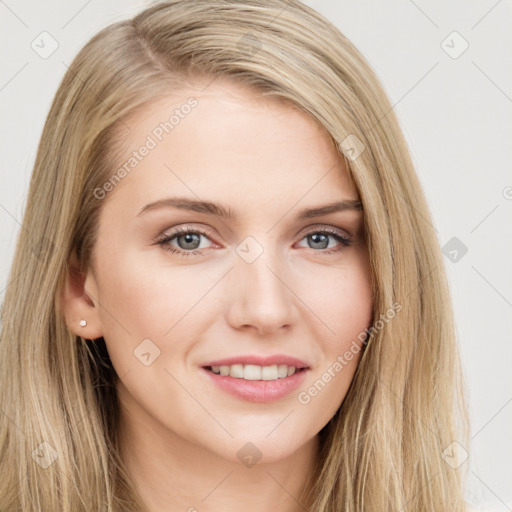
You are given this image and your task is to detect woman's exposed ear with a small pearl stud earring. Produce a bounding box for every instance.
[59,249,103,340]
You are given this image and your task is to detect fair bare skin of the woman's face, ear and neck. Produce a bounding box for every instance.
[64,79,373,512]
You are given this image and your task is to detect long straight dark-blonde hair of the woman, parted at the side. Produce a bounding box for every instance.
[0,0,469,512]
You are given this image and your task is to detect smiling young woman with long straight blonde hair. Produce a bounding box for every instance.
[0,0,467,512]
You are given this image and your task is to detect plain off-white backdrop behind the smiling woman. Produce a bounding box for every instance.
[0,0,512,512]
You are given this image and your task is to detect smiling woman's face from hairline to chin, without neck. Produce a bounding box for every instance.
[79,80,372,462]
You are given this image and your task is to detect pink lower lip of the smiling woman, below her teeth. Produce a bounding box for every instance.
[201,368,308,403]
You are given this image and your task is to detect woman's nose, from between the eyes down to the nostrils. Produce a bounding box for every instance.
[226,244,299,335]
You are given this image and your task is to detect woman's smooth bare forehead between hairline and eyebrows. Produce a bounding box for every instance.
[102,80,358,215]
